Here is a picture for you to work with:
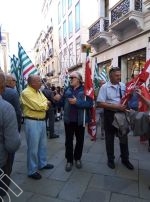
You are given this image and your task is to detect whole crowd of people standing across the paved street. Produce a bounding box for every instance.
[0,67,150,197]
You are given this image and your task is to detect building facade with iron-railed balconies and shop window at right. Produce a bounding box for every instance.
[88,0,150,82]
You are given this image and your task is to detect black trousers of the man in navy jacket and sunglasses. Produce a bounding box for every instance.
[65,123,85,163]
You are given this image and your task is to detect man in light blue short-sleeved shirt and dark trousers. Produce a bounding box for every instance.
[97,67,134,170]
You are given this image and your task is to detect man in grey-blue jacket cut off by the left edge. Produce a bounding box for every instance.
[0,73,21,198]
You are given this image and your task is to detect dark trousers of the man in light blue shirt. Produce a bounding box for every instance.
[104,110,129,161]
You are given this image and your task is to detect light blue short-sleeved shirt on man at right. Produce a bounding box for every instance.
[97,81,126,104]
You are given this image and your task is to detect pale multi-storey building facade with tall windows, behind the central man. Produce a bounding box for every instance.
[35,0,98,85]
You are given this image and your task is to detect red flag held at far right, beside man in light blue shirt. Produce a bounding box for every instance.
[121,60,150,104]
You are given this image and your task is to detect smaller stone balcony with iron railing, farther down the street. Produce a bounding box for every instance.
[88,17,111,49]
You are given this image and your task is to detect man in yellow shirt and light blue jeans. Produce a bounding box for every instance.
[20,75,54,180]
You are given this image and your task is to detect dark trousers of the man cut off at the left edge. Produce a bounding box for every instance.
[0,155,12,197]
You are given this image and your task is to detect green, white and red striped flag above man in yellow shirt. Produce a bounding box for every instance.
[18,42,38,86]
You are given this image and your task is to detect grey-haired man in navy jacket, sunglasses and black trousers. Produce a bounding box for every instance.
[64,71,93,172]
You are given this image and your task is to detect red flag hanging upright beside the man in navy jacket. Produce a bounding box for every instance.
[84,54,96,140]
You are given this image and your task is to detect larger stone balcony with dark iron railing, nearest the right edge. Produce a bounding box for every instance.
[109,0,144,41]
